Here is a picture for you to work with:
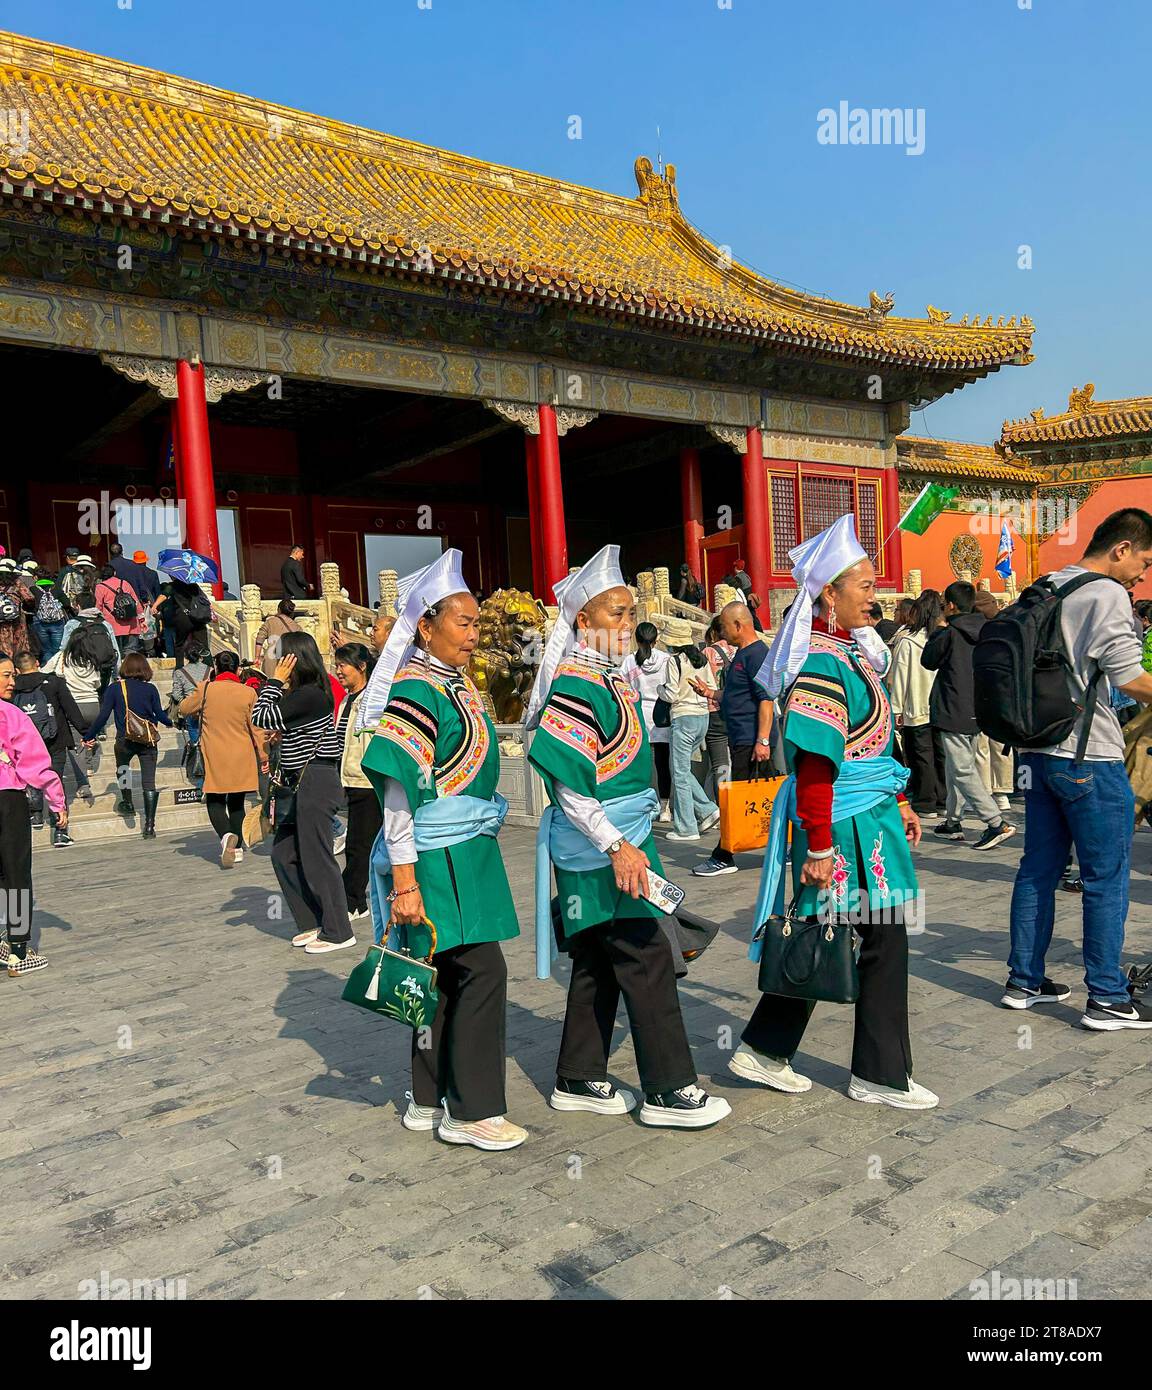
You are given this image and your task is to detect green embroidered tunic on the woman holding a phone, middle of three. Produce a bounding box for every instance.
[528,651,664,938]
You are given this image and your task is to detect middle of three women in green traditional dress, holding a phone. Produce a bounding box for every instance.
[525,545,731,1129]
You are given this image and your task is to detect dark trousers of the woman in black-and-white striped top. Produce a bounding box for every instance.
[272,759,352,941]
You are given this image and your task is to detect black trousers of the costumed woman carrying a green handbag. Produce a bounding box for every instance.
[411,934,509,1122]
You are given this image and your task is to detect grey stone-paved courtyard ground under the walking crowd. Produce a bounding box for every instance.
[0,811,1152,1300]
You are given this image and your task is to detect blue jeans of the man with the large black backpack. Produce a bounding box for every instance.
[1007,753,1135,1004]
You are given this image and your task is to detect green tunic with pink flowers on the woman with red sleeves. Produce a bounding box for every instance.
[782,631,917,920]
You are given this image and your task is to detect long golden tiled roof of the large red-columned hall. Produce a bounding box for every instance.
[0,33,1032,371]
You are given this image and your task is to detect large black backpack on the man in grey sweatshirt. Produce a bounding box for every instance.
[971,574,1114,760]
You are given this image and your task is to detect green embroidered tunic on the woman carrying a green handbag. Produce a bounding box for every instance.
[361,657,520,951]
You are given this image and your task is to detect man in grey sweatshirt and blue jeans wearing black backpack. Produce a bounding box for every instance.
[977,507,1152,1033]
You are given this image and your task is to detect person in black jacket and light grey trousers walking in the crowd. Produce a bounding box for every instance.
[920,580,1016,851]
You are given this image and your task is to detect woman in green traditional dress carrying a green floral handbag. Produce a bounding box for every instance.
[359,550,528,1150]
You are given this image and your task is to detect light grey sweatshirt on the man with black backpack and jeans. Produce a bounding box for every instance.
[1038,564,1144,762]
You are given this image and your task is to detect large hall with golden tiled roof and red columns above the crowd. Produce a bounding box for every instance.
[0,35,1033,606]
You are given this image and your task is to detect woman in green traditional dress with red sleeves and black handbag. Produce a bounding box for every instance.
[728,516,938,1109]
